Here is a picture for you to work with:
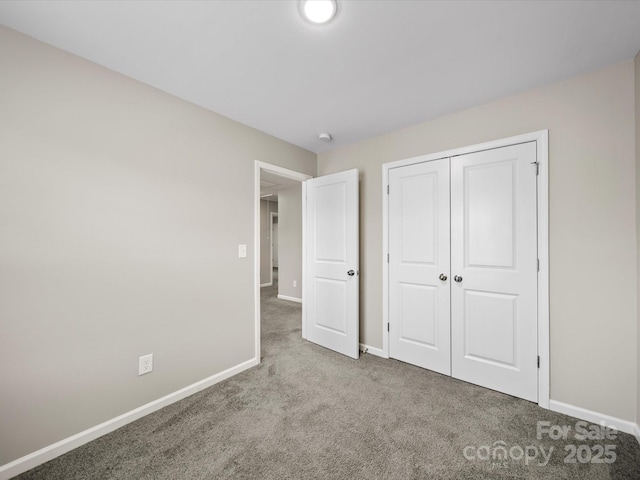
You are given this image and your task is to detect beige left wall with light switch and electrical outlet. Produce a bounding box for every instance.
[0,27,316,465]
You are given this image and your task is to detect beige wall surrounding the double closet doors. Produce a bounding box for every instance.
[318,61,638,420]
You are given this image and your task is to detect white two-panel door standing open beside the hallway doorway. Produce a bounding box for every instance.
[303,170,359,358]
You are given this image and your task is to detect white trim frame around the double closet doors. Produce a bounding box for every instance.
[381,130,550,409]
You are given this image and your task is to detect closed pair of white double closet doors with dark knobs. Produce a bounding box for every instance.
[389,142,538,401]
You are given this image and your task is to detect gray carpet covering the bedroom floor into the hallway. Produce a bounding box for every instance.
[12,272,640,480]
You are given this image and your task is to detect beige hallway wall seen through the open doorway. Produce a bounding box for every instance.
[278,184,302,300]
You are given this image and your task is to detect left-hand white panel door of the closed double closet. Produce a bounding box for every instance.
[389,158,451,375]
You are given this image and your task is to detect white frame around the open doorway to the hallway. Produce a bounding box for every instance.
[253,160,313,363]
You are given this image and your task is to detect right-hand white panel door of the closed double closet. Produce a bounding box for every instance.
[451,142,538,401]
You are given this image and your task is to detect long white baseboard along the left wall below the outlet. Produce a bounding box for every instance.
[0,358,260,480]
